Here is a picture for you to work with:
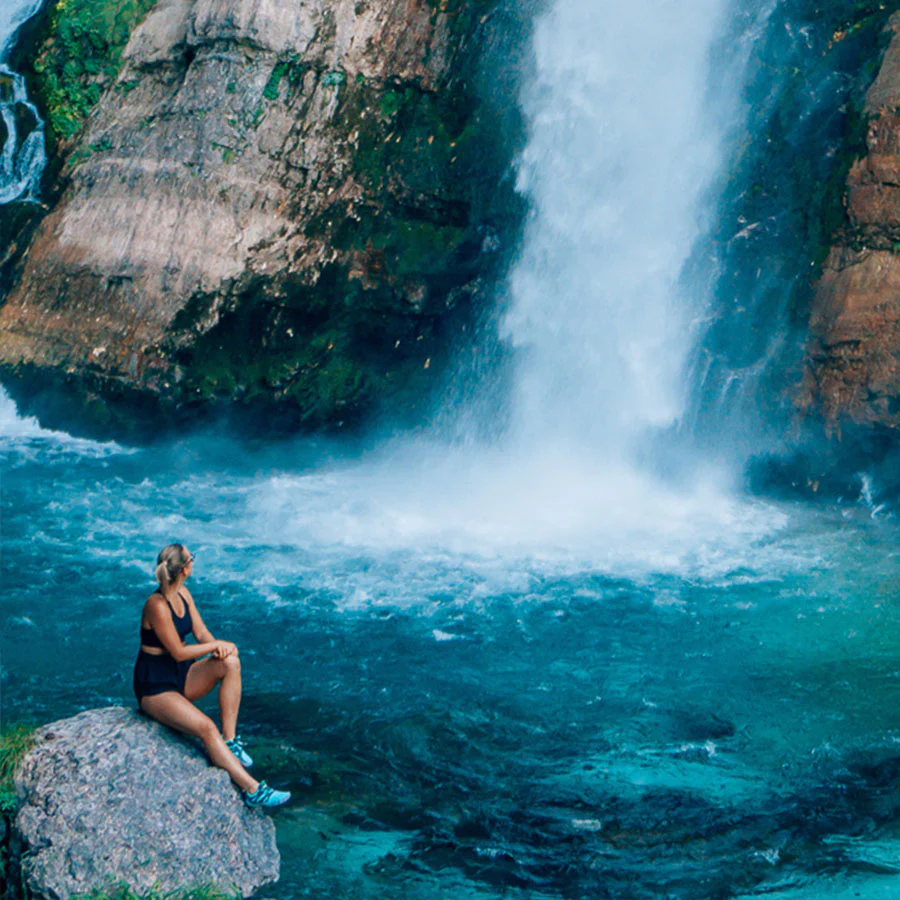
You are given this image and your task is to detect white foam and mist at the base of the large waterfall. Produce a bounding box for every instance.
[239,445,788,577]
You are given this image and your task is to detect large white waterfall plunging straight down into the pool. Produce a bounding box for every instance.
[504,0,764,462]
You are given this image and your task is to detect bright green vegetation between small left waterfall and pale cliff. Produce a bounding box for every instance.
[34,0,156,140]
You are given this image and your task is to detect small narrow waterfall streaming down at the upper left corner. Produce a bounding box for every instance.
[0,0,47,205]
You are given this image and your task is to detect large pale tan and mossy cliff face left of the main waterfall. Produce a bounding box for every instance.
[0,0,528,425]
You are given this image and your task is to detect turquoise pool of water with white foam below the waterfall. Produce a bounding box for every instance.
[0,402,900,900]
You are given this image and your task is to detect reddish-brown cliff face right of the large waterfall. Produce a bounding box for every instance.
[800,13,900,435]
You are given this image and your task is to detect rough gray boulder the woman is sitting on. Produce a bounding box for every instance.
[10,707,280,900]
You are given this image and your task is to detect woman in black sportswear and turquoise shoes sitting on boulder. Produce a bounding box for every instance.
[134,544,291,807]
